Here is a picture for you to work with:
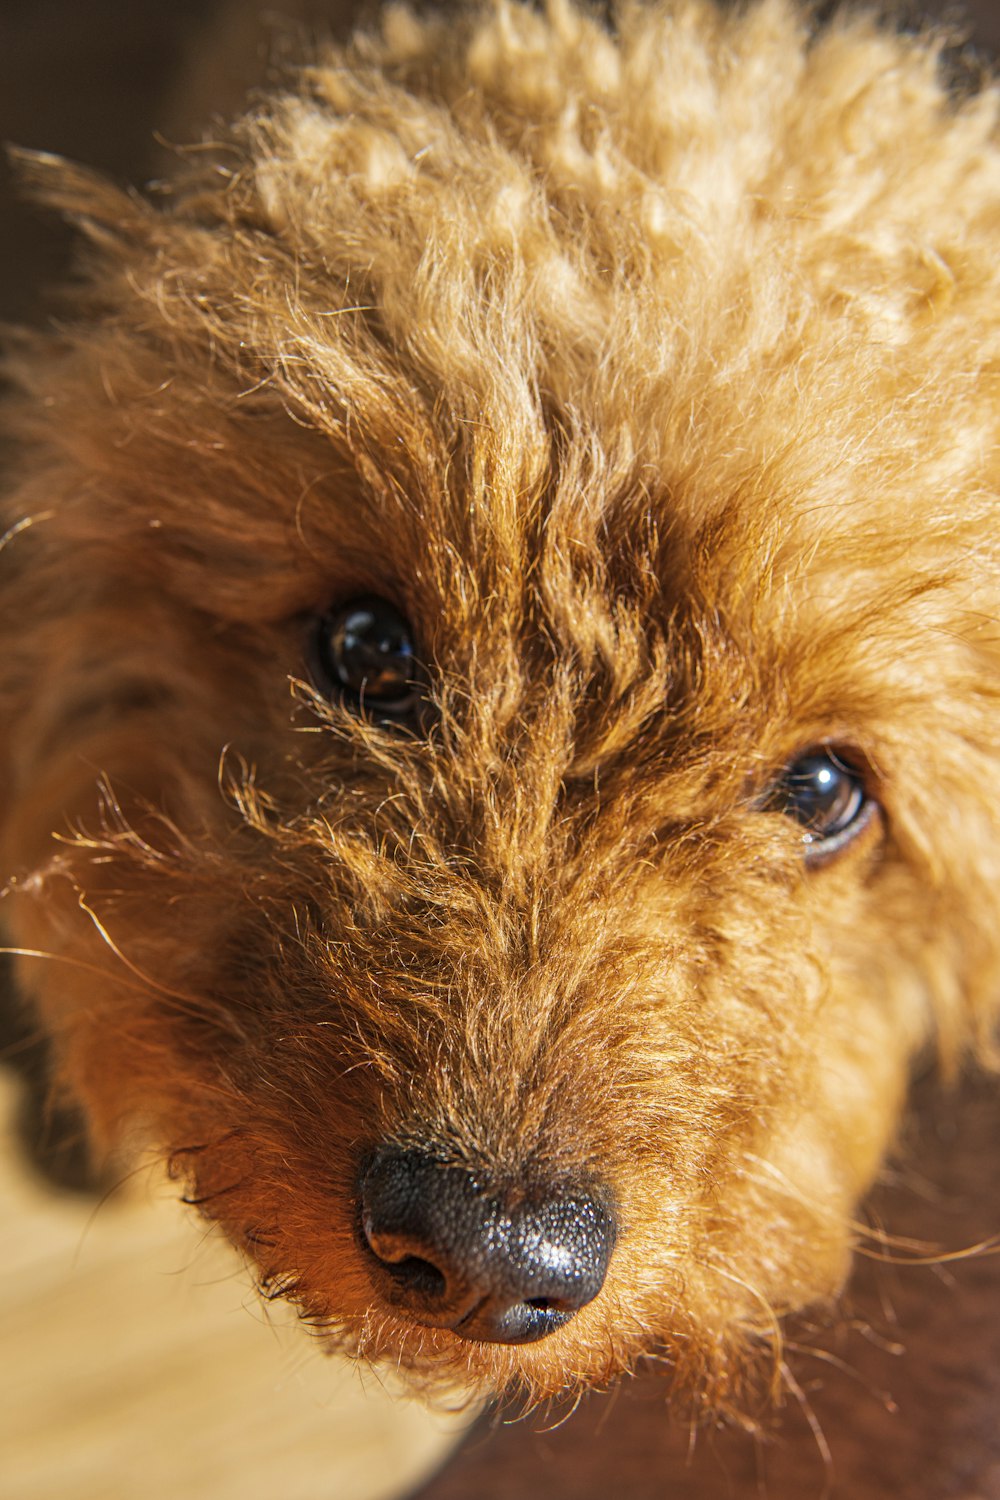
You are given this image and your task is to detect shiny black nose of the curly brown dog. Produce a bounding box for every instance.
[360,1148,615,1344]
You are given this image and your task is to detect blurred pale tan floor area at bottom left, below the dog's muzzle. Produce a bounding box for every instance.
[0,1073,468,1500]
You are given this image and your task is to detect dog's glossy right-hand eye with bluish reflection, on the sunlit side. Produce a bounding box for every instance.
[765,746,876,864]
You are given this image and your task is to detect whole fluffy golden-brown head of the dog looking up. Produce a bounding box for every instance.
[3,3,1000,1406]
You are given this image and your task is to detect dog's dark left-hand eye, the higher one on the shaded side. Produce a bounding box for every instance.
[315,594,421,719]
